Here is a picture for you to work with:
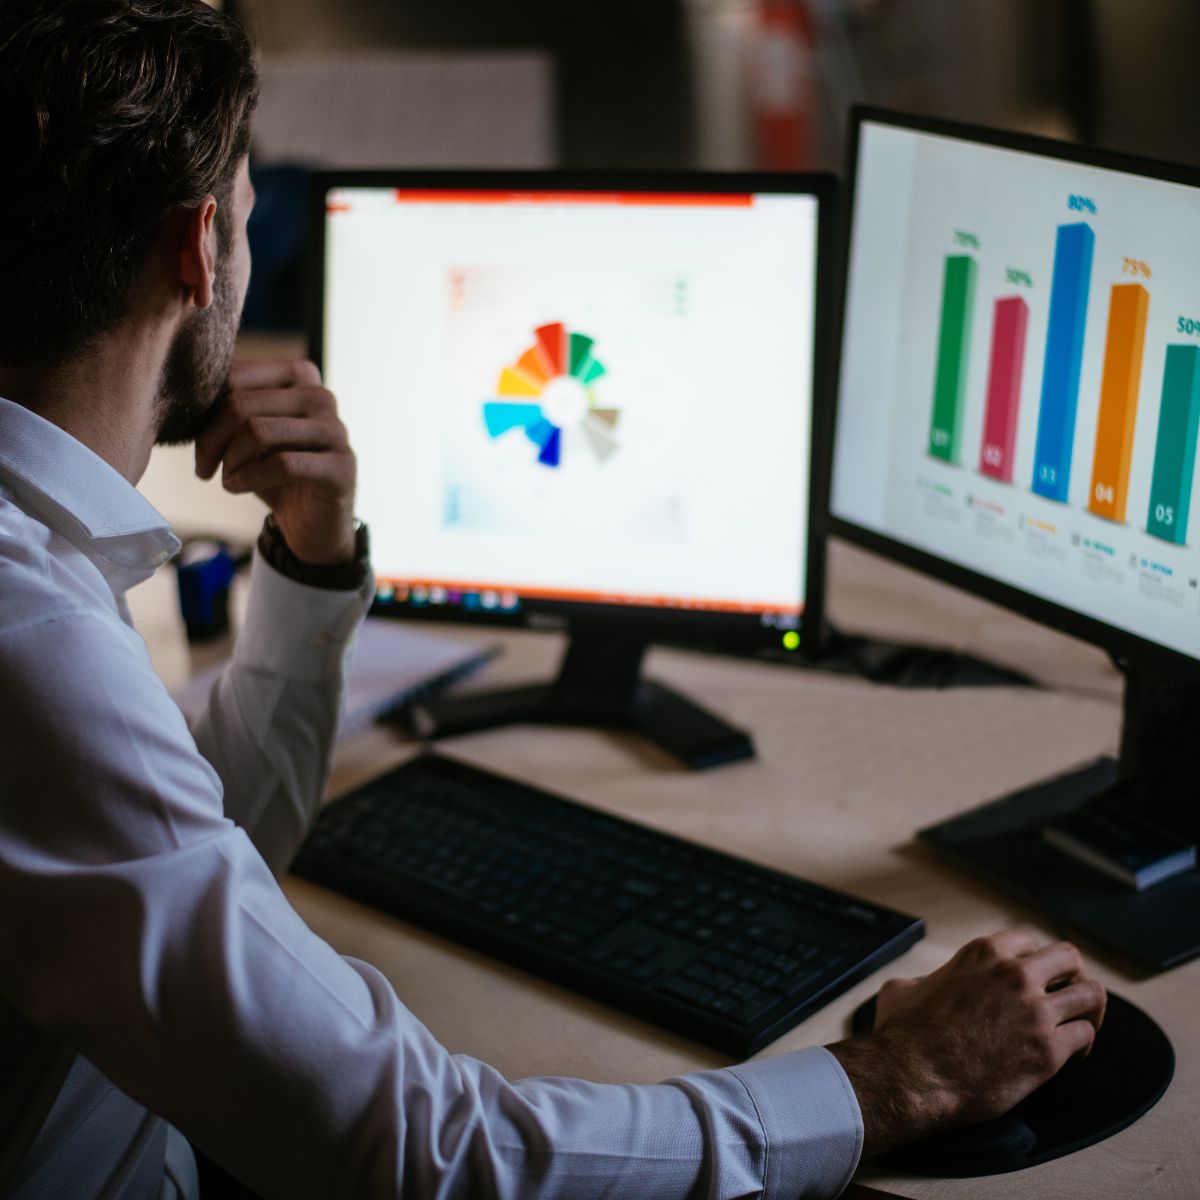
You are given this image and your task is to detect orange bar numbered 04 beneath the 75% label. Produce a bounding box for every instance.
[1087,283,1150,524]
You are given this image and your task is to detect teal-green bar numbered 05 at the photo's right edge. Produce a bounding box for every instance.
[1146,346,1200,546]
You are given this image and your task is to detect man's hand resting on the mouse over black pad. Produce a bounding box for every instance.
[829,929,1108,1156]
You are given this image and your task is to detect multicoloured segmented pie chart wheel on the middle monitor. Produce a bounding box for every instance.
[484,322,620,467]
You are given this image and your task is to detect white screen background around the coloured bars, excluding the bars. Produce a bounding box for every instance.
[833,122,1200,656]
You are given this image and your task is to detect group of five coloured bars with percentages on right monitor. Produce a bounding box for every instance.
[926,205,1200,546]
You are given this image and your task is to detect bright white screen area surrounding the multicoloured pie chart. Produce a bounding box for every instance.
[324,188,817,613]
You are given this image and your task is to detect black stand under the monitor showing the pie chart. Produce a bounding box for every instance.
[412,620,755,770]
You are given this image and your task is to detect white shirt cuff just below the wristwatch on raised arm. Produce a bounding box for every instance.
[234,550,374,683]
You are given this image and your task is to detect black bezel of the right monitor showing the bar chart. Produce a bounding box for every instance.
[820,104,1200,682]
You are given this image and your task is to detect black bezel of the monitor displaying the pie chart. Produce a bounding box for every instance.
[307,168,838,659]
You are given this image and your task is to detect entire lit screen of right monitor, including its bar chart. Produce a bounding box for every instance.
[830,120,1200,661]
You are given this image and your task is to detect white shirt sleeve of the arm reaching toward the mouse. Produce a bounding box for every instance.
[0,613,862,1200]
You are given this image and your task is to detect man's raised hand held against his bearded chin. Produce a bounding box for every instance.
[196,361,356,566]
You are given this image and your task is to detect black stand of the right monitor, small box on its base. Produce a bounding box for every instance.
[917,665,1200,971]
